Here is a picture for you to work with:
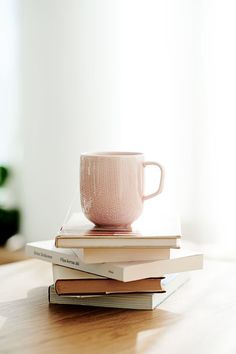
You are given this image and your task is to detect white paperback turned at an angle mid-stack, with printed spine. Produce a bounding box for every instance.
[26,240,203,282]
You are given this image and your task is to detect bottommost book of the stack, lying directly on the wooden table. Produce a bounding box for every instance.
[48,273,189,310]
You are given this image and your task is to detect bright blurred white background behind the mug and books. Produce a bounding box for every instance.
[0,0,236,259]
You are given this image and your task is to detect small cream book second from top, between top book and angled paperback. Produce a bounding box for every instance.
[73,247,170,264]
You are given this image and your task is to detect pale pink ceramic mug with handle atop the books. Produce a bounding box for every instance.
[80,152,164,227]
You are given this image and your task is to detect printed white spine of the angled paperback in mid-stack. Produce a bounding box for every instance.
[26,245,123,281]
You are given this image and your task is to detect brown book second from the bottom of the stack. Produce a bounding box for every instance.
[53,264,164,295]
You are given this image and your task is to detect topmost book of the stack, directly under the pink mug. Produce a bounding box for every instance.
[55,214,181,248]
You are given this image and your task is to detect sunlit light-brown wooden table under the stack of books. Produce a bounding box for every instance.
[0,260,236,354]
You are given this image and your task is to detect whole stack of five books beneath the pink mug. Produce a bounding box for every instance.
[26,215,203,310]
